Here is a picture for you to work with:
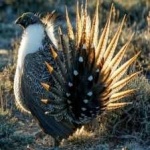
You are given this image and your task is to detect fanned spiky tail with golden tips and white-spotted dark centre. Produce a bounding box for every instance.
[42,1,139,124]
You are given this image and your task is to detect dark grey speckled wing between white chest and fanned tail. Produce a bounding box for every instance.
[21,51,76,139]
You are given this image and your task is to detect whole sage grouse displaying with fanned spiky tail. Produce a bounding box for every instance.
[14,0,139,147]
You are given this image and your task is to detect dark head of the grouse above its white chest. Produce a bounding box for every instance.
[15,12,41,28]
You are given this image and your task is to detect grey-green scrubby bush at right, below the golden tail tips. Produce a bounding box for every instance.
[97,75,150,141]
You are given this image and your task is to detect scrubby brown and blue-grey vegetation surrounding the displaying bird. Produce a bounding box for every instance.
[0,0,150,150]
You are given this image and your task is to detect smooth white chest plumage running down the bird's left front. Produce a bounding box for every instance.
[14,24,44,113]
